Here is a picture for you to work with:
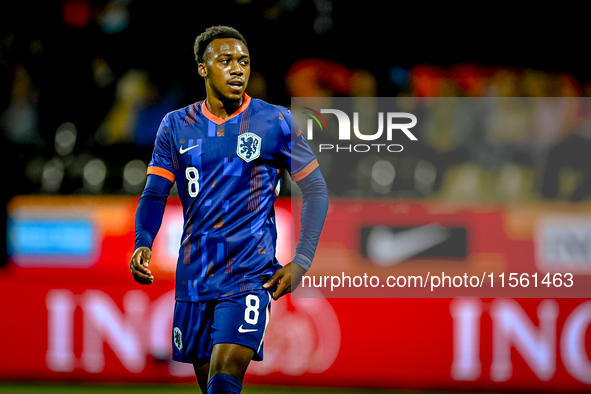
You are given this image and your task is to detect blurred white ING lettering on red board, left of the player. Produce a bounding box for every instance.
[46,290,174,373]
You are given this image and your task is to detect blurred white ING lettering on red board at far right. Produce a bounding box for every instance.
[450,299,591,384]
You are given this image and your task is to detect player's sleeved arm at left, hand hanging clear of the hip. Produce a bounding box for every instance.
[129,115,174,285]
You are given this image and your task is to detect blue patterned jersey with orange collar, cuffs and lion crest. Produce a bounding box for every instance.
[148,94,318,302]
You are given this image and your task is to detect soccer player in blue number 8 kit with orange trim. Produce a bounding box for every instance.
[130,26,328,393]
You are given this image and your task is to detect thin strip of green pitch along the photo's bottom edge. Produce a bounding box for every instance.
[0,382,500,394]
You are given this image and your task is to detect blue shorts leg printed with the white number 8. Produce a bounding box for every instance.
[212,290,271,361]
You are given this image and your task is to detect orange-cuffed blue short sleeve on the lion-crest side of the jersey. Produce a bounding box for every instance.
[279,108,318,182]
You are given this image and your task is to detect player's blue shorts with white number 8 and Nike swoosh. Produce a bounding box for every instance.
[172,290,271,365]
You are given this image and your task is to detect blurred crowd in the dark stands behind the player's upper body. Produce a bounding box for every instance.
[0,0,591,201]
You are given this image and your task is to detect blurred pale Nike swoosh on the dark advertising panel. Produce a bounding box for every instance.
[367,223,451,267]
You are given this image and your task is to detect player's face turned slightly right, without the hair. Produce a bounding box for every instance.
[199,38,250,100]
